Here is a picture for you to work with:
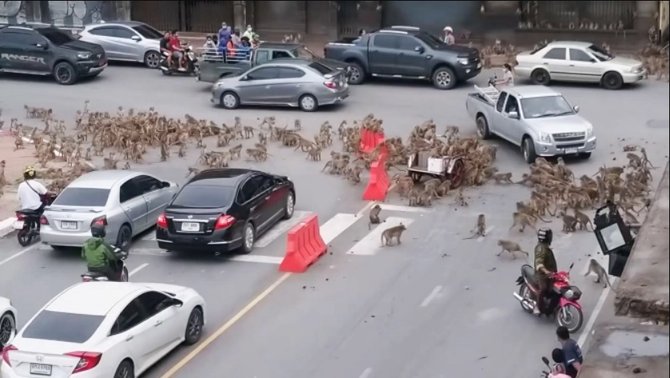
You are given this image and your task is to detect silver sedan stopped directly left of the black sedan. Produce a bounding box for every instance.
[40,170,178,249]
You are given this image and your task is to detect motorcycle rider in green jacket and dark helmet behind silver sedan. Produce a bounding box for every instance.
[81,223,119,281]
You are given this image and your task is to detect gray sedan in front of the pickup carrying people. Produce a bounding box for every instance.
[211,59,349,112]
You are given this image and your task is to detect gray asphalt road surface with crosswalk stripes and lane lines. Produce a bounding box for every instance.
[0,66,668,378]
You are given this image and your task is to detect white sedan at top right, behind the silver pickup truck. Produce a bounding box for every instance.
[514,41,646,89]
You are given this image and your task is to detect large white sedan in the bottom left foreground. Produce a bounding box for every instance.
[0,281,205,378]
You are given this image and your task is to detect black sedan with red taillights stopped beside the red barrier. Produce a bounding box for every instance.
[156,168,295,253]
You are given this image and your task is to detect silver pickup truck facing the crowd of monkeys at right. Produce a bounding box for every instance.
[465,85,596,163]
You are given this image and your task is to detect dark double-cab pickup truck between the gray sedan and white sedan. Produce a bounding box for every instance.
[324,26,482,89]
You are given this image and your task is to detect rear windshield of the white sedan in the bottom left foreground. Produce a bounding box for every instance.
[23,310,105,343]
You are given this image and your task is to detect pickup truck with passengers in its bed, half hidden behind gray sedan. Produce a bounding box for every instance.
[196,42,347,83]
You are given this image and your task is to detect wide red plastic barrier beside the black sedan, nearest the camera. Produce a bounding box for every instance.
[279,215,328,273]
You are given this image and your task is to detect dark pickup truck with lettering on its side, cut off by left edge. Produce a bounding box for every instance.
[0,25,107,85]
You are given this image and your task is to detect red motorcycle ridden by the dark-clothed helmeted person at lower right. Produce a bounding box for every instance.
[513,264,584,333]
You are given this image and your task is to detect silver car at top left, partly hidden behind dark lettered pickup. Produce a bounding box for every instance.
[79,21,163,68]
